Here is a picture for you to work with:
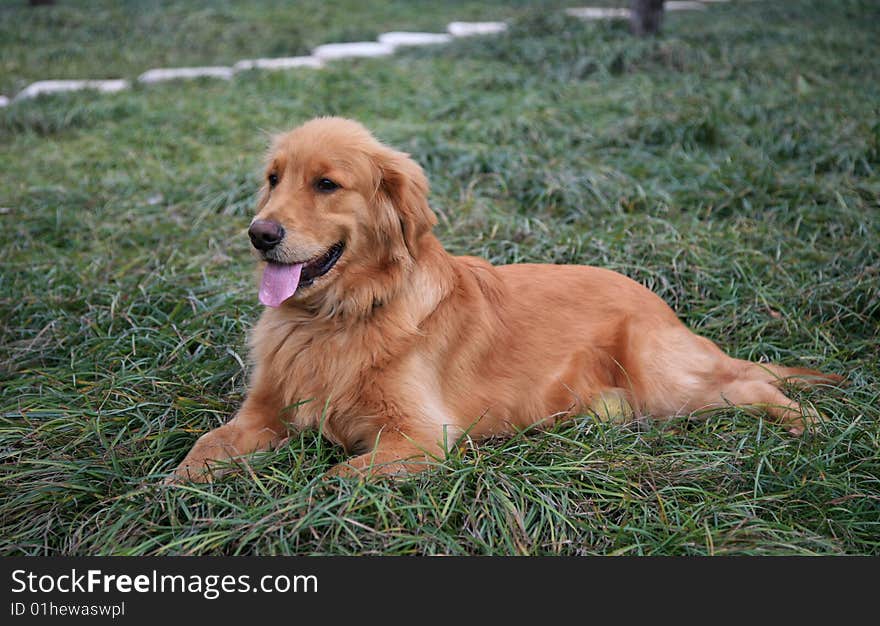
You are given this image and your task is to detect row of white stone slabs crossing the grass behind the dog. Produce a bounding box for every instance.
[0,0,728,107]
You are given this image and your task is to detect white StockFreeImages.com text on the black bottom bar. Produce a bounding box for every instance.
[12,569,318,600]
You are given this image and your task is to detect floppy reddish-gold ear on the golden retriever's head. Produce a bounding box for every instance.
[376,148,437,258]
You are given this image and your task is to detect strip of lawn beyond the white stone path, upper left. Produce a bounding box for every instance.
[0,0,596,96]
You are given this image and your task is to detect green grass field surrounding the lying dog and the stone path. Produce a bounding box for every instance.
[0,0,880,555]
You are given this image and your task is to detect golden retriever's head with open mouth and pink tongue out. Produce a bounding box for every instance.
[248,117,437,307]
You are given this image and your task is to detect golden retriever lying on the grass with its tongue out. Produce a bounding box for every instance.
[171,117,841,480]
